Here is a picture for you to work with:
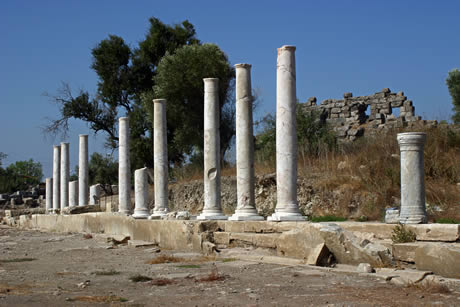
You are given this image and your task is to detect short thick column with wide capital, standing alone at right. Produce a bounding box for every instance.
[397,132,427,224]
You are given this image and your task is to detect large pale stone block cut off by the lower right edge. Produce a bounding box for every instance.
[415,243,460,278]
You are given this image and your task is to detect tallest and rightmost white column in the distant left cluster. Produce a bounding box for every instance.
[78,134,89,206]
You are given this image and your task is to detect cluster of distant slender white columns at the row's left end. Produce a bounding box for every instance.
[45,134,89,213]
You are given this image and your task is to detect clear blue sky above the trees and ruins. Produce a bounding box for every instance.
[0,0,460,176]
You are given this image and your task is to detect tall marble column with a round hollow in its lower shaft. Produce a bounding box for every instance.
[197,78,227,220]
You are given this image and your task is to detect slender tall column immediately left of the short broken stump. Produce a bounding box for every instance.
[118,117,131,214]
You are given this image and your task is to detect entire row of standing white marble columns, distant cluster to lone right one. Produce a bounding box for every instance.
[46,46,426,223]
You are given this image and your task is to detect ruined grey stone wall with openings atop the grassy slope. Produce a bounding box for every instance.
[303,88,437,141]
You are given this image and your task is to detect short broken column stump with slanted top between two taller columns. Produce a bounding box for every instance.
[133,167,149,219]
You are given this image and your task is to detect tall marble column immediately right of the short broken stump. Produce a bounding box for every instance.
[152,99,168,218]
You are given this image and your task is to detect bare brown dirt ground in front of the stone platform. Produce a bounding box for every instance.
[0,225,460,306]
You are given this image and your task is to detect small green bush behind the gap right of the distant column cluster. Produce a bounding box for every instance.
[88,152,118,192]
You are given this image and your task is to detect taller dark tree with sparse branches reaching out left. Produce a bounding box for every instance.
[45,18,200,169]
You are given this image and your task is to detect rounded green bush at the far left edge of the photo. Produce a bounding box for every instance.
[0,159,43,193]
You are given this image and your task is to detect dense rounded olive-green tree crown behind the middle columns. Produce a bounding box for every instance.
[143,44,235,163]
